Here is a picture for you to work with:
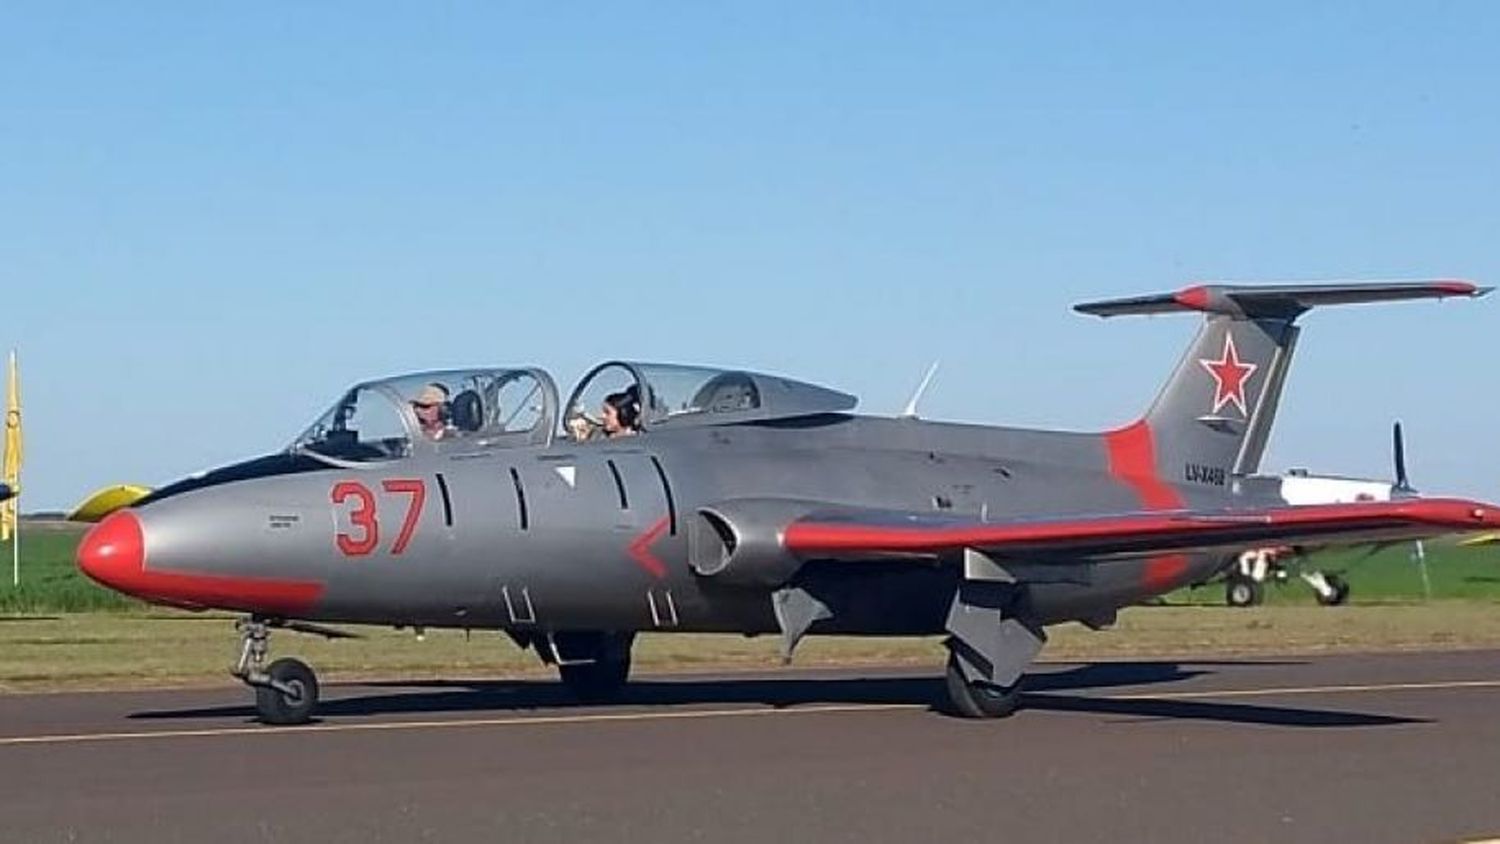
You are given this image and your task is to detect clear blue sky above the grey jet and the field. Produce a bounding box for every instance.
[0,3,1500,510]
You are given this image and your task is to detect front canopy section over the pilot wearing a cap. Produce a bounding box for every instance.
[291,369,557,462]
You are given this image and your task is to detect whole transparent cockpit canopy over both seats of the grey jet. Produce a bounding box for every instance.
[290,361,857,465]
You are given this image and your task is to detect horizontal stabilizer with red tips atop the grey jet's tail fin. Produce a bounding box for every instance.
[1073,279,1493,319]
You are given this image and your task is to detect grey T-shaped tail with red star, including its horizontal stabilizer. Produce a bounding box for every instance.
[1074,280,1491,484]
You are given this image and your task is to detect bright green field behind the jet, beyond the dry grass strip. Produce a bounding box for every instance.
[0,522,1500,615]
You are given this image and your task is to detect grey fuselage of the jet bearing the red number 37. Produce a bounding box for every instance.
[137,414,1248,634]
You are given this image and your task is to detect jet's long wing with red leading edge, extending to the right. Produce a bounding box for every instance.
[782,498,1500,559]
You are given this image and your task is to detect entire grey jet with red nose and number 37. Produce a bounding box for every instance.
[78,280,1500,724]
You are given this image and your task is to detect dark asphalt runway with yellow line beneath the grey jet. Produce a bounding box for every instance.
[0,652,1500,843]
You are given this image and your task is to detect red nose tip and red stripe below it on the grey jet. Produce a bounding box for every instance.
[78,510,323,615]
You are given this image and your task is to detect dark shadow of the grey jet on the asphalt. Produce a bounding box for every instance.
[131,661,1419,727]
